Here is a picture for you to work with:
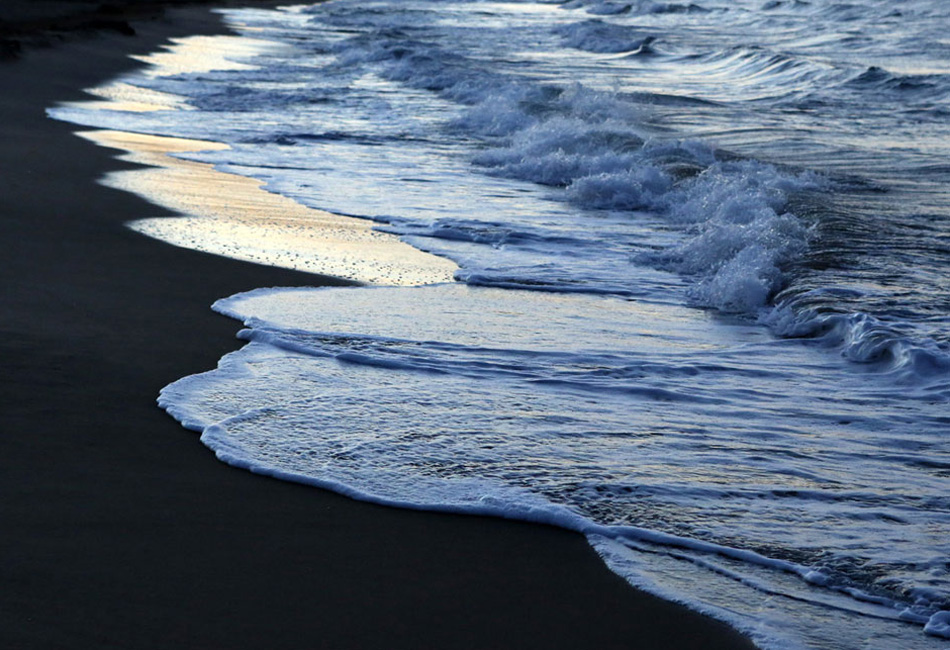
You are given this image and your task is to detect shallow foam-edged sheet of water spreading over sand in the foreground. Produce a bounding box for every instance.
[160,285,950,647]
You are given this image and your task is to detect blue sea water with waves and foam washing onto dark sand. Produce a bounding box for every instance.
[51,0,950,649]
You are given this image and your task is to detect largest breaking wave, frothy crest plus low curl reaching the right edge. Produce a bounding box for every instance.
[459,87,948,374]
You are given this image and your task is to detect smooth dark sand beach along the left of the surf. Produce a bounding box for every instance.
[0,2,751,649]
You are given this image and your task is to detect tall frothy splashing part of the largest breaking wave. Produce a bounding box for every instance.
[473,88,823,313]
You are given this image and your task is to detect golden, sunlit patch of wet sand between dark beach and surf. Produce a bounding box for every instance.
[77,129,458,286]
